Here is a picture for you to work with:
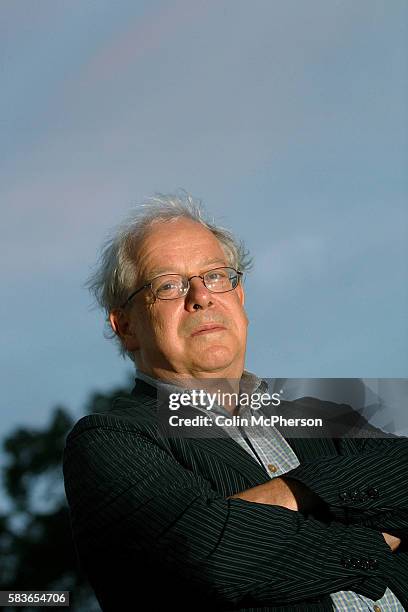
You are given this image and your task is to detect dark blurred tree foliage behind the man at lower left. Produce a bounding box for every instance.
[0,380,129,612]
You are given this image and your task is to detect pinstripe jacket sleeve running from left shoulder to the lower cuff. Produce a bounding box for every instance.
[64,420,393,605]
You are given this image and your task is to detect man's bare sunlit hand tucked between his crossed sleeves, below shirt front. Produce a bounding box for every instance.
[231,477,322,511]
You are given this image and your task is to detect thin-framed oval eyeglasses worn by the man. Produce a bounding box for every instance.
[122,267,243,308]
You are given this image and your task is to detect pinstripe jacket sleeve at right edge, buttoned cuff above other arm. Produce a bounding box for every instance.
[286,416,408,535]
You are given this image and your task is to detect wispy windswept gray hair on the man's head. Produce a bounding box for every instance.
[85,192,252,361]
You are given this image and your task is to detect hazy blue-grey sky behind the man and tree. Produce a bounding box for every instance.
[0,0,408,444]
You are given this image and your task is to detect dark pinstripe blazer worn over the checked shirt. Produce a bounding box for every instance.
[63,381,408,612]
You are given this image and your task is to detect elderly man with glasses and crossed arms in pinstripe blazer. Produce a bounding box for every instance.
[64,196,408,612]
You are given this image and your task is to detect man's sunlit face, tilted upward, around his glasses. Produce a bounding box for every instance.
[111,218,248,379]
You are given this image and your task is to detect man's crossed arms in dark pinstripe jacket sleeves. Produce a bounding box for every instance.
[64,415,408,606]
